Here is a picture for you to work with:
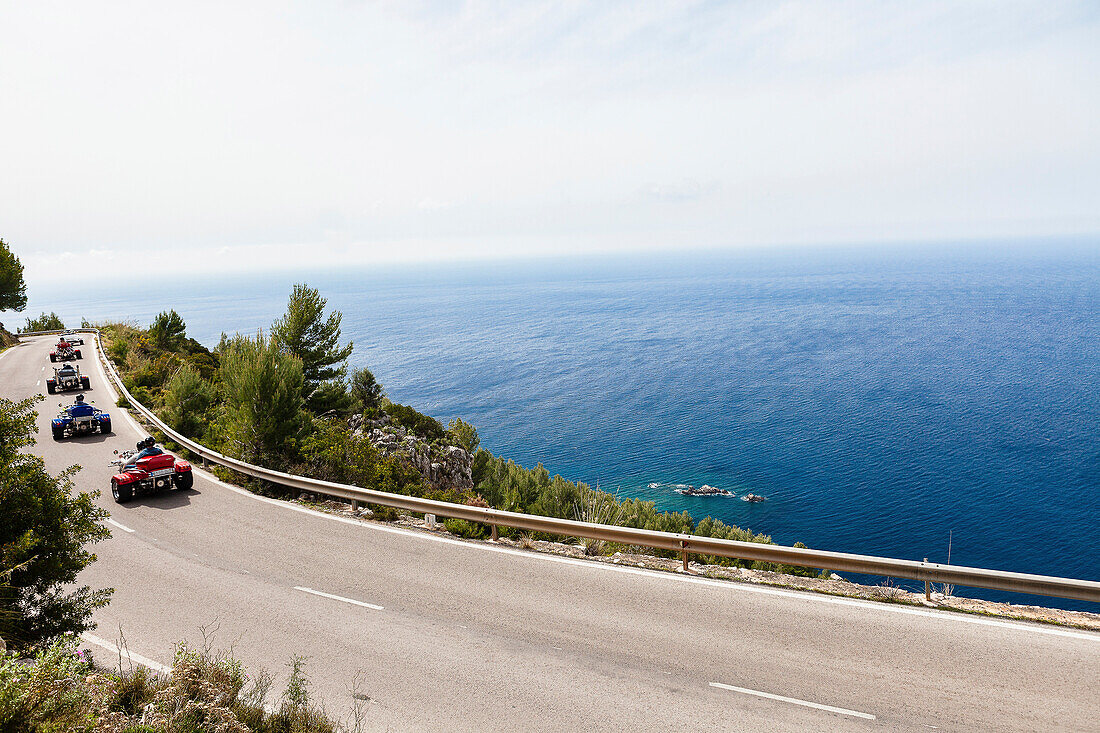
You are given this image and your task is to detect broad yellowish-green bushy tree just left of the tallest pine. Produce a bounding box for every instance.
[218,333,308,468]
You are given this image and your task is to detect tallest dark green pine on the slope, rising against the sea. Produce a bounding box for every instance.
[272,283,352,415]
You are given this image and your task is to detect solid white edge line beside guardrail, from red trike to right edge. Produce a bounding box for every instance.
[193,467,1100,642]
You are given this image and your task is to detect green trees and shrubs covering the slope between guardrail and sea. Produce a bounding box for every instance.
[101,284,817,575]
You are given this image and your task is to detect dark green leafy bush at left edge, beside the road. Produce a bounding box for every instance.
[0,396,110,647]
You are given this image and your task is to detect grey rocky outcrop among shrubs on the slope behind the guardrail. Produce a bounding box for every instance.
[348,414,474,491]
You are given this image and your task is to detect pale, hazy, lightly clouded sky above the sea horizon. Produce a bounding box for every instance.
[0,0,1100,283]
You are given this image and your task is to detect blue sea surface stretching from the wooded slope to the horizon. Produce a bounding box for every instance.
[21,242,1100,610]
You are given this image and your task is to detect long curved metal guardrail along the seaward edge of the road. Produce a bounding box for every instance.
[17,329,1100,603]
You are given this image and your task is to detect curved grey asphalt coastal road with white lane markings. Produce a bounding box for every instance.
[0,337,1100,731]
